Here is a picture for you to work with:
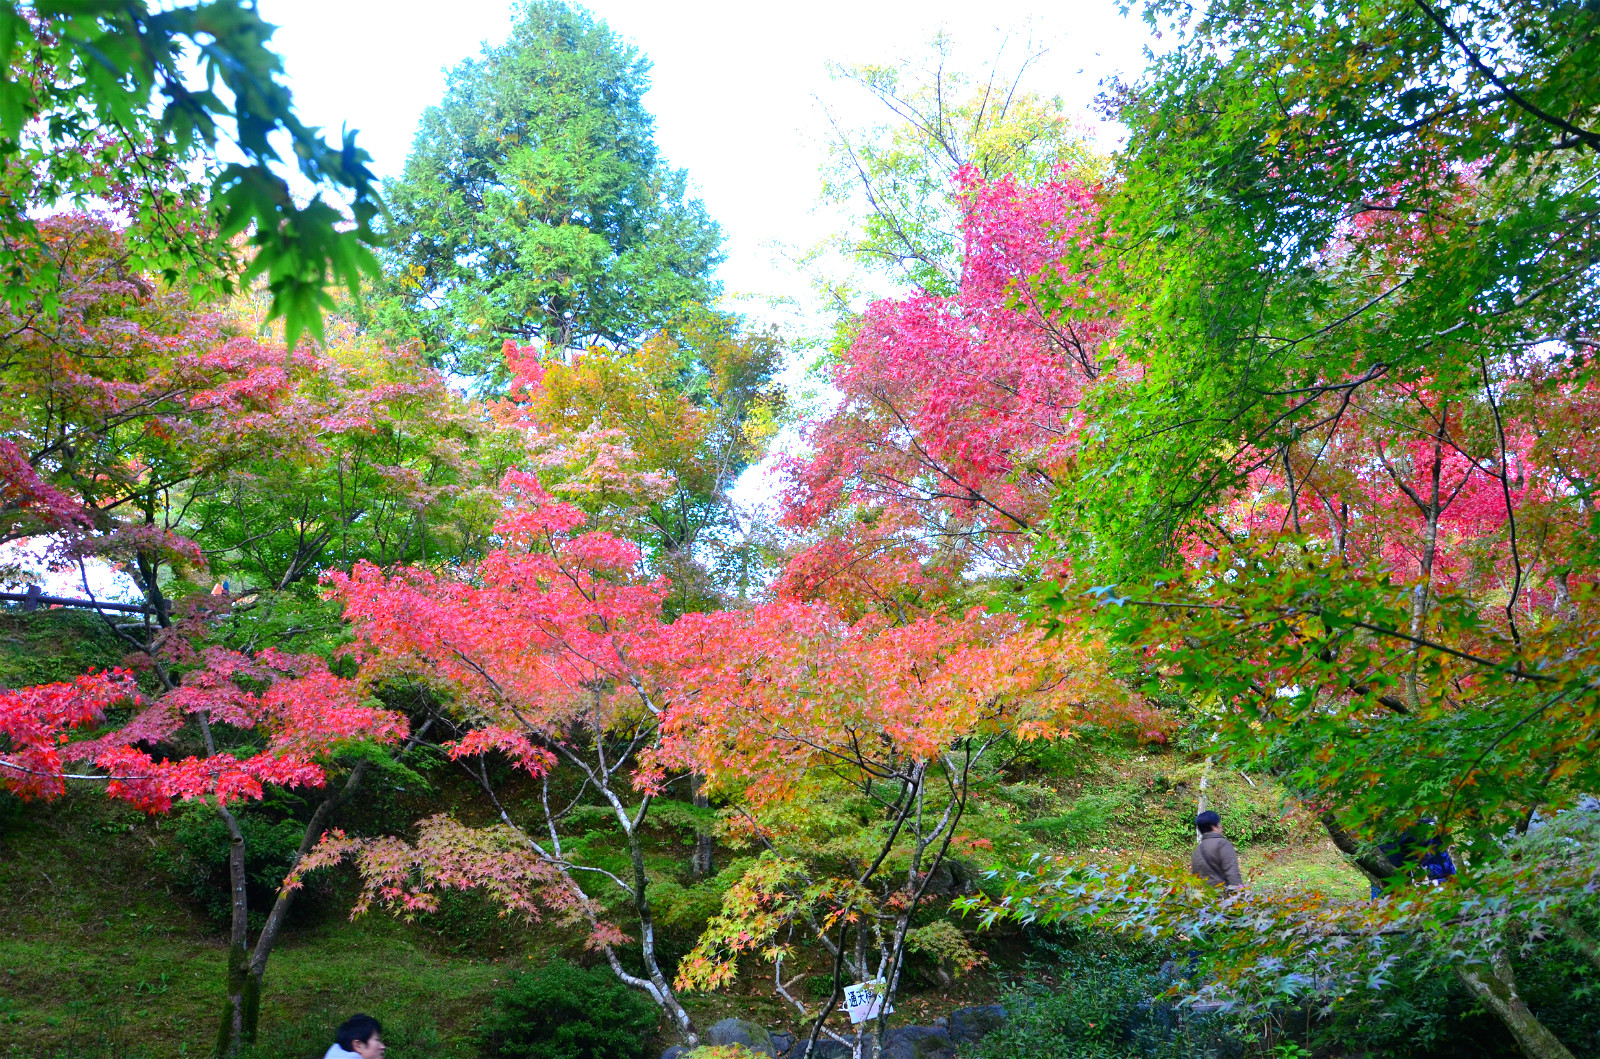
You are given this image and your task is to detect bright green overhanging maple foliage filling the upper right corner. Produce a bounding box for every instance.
[1045,0,1600,579]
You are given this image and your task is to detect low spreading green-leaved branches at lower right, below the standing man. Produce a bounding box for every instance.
[958,808,1600,1059]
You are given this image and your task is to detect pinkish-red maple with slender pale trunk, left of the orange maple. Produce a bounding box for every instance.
[288,470,696,1043]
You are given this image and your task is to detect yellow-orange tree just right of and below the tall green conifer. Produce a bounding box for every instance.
[496,310,784,877]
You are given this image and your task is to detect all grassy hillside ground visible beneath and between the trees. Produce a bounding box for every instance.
[0,611,1363,1059]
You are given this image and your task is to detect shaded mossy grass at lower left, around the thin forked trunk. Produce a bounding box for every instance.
[0,793,506,1059]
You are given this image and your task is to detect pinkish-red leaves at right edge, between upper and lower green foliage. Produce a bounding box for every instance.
[1186,372,1600,614]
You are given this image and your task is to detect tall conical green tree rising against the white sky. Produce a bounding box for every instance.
[387,0,722,382]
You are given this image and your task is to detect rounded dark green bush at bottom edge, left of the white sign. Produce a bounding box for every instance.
[478,960,658,1059]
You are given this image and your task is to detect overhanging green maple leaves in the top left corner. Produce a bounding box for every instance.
[0,0,382,346]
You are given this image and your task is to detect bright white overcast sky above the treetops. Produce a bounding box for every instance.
[259,0,1146,323]
